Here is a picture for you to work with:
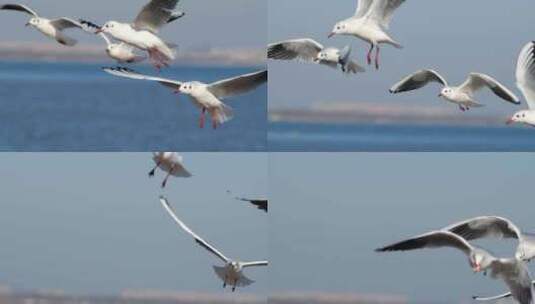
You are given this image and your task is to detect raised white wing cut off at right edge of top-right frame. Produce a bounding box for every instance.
[516,41,535,110]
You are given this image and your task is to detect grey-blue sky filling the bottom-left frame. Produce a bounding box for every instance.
[0,153,268,295]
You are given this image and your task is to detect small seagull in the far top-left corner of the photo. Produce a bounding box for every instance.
[0,4,83,46]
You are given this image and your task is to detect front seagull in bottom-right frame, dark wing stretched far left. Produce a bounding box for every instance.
[376,230,533,304]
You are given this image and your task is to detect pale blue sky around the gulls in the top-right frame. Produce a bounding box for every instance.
[268,0,535,115]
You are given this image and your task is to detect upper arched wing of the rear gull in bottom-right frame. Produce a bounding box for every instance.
[443,216,522,241]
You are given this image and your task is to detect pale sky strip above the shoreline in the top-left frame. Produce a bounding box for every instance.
[0,0,267,48]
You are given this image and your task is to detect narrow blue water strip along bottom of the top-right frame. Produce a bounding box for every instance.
[268,123,535,152]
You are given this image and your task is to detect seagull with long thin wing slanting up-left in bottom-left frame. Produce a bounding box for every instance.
[160,196,268,292]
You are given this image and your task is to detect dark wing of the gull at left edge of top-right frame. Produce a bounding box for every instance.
[268,38,323,61]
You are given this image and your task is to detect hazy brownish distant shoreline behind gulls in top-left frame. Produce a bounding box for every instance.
[0,42,266,66]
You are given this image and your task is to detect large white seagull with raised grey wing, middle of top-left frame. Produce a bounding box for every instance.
[90,0,184,69]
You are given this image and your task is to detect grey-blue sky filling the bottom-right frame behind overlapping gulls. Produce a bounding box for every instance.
[270,153,535,303]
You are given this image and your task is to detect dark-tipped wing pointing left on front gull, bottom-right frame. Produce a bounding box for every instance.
[375,231,472,255]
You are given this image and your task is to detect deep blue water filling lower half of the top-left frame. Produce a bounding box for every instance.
[0,62,267,151]
